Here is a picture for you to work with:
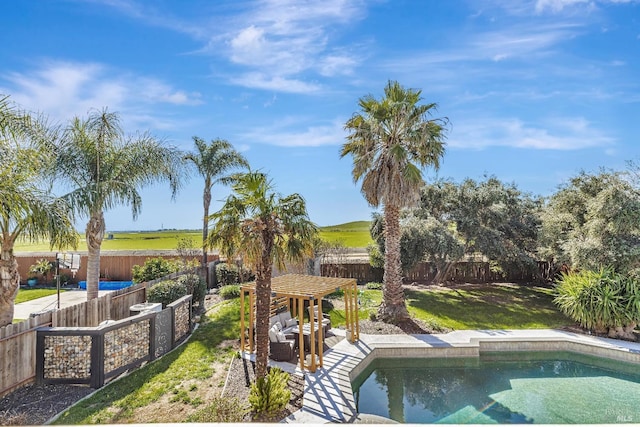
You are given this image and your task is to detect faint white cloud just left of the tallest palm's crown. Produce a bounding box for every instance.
[242,118,347,147]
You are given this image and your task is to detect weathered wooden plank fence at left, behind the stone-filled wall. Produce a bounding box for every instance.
[0,283,147,397]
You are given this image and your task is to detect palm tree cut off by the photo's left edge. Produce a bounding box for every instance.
[0,98,78,326]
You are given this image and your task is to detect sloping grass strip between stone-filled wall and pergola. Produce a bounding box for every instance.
[55,299,240,425]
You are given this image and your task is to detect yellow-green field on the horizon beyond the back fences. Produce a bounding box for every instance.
[15,221,372,252]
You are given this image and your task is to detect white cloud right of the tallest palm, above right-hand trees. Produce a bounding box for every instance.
[448,117,615,150]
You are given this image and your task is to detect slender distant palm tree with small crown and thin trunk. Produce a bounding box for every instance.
[184,136,249,270]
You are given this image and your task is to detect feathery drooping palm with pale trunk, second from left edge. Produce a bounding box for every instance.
[55,109,184,300]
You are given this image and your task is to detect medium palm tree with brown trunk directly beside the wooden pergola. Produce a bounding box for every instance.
[209,171,317,378]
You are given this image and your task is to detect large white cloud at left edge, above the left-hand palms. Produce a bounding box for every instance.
[0,61,201,126]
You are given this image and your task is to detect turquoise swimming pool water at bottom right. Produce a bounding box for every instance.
[353,352,640,424]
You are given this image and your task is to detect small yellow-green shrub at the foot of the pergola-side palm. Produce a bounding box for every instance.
[249,367,291,415]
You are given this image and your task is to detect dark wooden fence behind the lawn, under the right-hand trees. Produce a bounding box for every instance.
[320,262,547,284]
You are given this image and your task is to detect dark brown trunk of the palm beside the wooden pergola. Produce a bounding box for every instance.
[256,232,273,378]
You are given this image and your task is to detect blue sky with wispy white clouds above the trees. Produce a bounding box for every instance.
[0,0,640,230]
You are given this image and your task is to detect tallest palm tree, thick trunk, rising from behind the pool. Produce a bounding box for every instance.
[341,81,448,323]
